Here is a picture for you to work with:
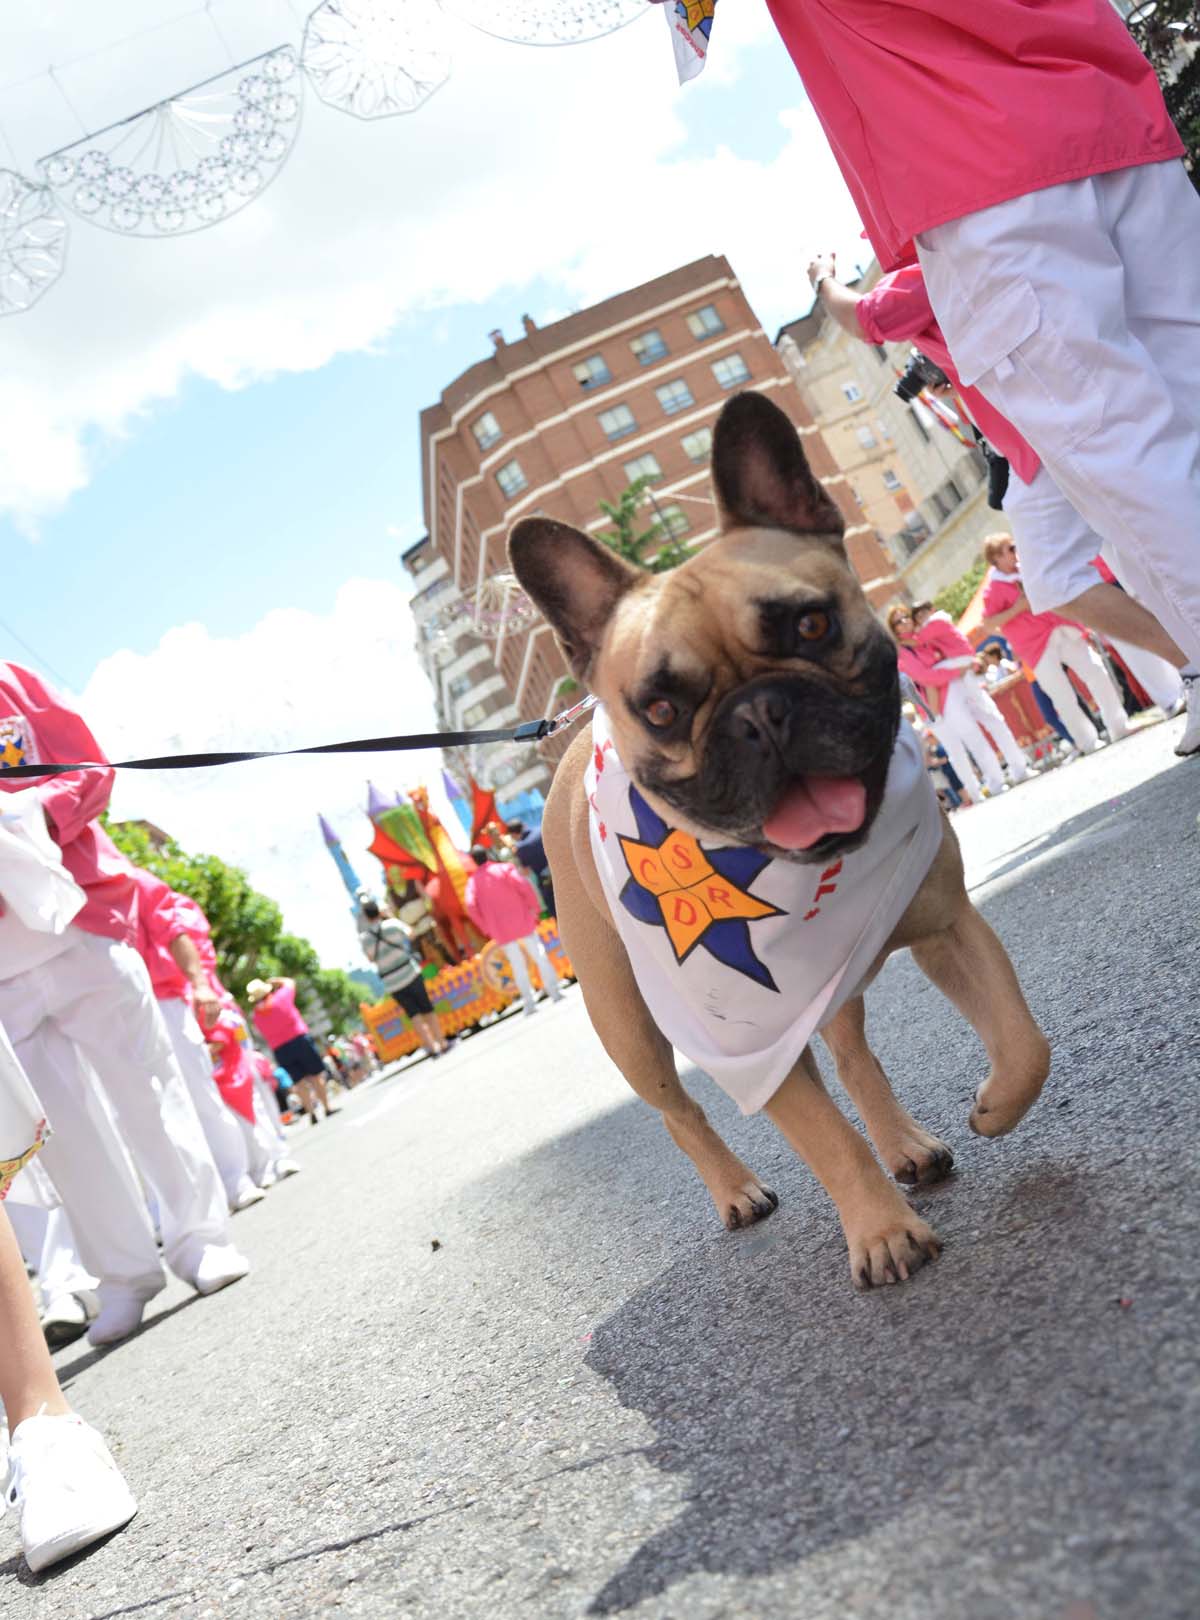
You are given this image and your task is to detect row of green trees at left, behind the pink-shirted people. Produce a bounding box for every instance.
[105,818,363,1034]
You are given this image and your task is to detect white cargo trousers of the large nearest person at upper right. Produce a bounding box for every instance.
[917,160,1200,661]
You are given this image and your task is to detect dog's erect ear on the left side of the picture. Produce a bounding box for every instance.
[509,517,643,680]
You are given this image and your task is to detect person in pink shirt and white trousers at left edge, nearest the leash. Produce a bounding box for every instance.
[0,663,249,1343]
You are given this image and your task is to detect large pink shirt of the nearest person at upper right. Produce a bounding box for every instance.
[768,0,1184,272]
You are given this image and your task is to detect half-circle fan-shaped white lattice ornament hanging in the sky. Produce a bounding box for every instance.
[39,45,301,237]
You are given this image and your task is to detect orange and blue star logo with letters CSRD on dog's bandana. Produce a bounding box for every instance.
[619,787,785,991]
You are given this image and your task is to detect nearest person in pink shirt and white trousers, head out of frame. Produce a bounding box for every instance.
[670,0,1200,677]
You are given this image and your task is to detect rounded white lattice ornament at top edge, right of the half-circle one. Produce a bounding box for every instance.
[300,0,450,118]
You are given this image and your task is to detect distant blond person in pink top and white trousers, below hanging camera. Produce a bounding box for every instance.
[981,535,1129,753]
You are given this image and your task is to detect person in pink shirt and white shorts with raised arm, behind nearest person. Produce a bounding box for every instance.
[808,254,1200,755]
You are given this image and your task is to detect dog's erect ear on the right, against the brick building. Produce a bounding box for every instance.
[713,392,845,549]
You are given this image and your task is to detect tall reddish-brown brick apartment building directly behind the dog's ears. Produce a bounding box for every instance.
[405,256,897,777]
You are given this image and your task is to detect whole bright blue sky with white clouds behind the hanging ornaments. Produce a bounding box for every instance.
[0,0,863,962]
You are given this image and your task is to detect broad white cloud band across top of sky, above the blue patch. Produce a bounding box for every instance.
[0,0,862,530]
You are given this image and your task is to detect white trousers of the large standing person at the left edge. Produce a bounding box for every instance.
[0,928,230,1280]
